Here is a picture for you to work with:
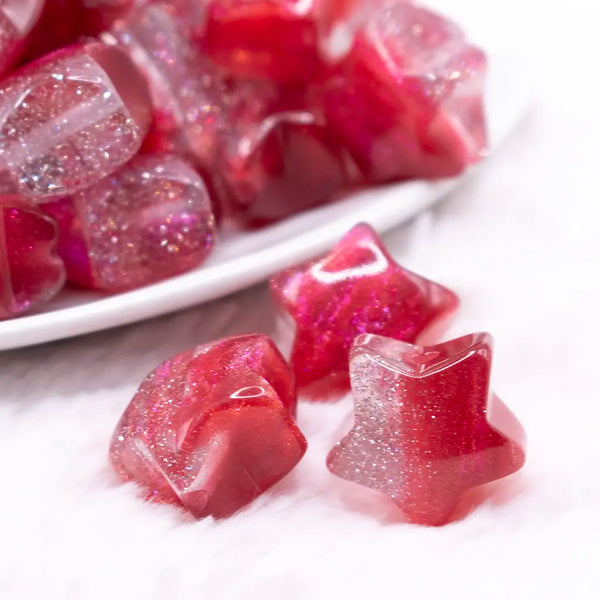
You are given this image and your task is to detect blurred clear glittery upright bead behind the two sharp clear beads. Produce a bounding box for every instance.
[102,2,226,172]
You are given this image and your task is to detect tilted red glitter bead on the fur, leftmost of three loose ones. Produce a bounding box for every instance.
[110,334,306,518]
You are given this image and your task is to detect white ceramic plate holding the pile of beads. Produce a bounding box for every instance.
[0,56,531,350]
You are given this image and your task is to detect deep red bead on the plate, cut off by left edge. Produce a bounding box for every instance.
[0,195,65,319]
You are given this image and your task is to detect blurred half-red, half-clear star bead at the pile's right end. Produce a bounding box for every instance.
[323,0,486,182]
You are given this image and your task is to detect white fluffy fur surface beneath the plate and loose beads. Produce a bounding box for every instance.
[0,0,600,600]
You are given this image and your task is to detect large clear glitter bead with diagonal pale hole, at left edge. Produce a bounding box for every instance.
[0,43,150,201]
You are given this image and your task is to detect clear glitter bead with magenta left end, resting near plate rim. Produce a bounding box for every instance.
[44,155,216,291]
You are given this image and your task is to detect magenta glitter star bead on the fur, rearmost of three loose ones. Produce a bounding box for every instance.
[271,224,458,394]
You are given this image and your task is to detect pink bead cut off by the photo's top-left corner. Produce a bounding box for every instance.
[0,0,44,75]
